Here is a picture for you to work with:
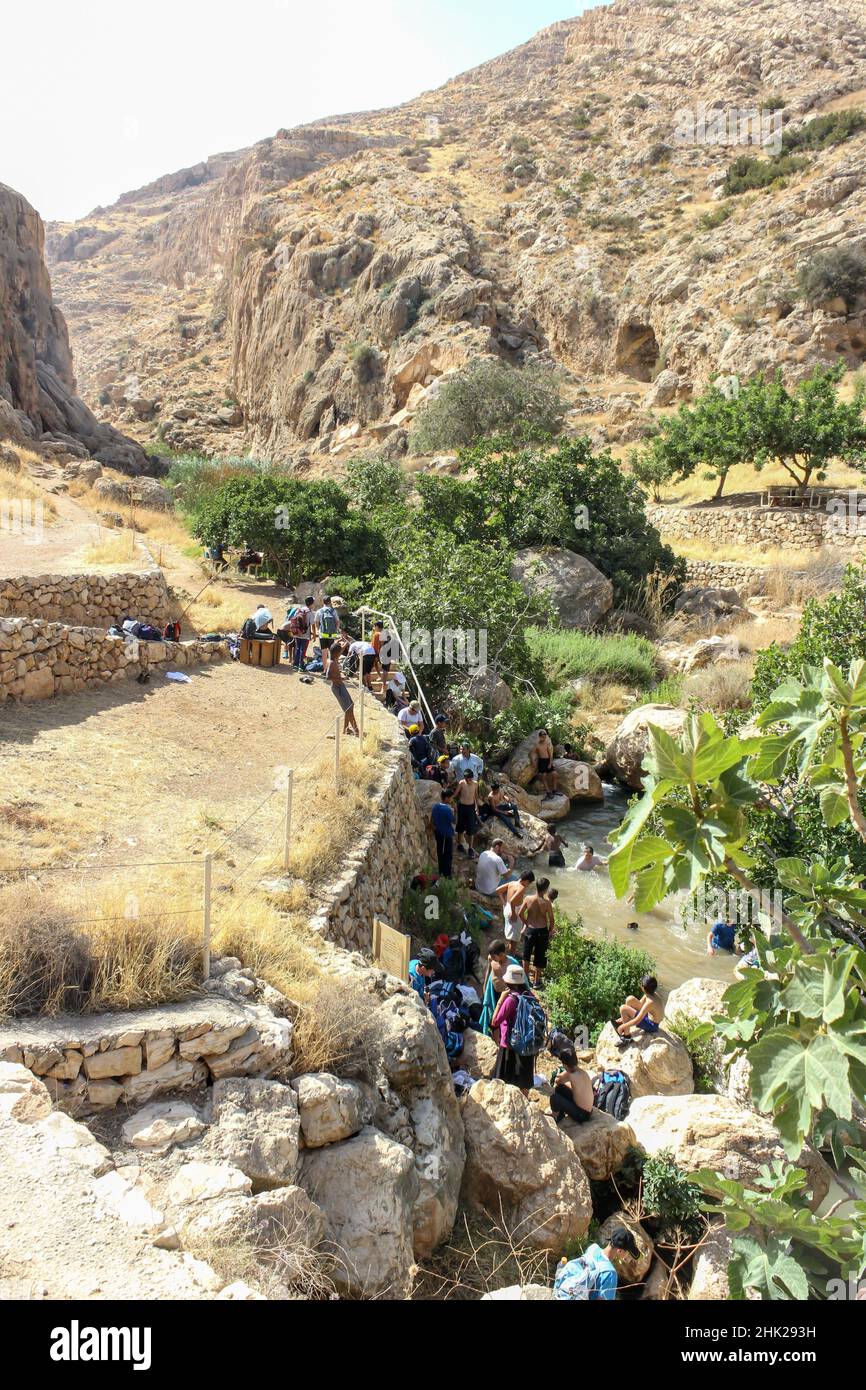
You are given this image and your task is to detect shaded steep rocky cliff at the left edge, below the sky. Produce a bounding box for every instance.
[0,183,147,473]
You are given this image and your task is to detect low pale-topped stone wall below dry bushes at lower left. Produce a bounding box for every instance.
[0,997,292,1115]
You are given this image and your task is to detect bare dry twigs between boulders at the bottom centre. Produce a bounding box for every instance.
[414,1211,553,1300]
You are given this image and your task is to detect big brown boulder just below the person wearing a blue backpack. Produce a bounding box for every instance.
[461,1081,592,1254]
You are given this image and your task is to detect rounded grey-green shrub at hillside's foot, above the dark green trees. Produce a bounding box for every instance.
[413,357,564,453]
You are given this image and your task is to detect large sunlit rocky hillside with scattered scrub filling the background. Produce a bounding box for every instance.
[47,0,866,467]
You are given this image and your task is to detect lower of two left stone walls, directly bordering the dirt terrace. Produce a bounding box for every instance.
[0,617,228,703]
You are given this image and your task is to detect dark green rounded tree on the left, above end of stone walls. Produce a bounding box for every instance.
[192,473,384,585]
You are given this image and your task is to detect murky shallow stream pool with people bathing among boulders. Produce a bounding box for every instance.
[532,785,735,995]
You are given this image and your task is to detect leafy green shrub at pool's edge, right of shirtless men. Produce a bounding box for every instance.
[542,913,655,1043]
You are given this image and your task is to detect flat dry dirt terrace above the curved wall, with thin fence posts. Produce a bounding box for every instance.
[0,662,348,873]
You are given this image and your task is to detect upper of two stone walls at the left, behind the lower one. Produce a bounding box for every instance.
[0,570,171,628]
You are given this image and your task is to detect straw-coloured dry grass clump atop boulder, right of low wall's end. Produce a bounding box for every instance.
[292,976,373,1077]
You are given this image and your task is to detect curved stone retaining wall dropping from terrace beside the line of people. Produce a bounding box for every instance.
[310,712,430,952]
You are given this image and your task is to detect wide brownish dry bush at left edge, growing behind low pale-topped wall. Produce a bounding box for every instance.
[0,884,202,1017]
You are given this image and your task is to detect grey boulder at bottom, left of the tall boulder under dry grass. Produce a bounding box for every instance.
[302,1126,418,1298]
